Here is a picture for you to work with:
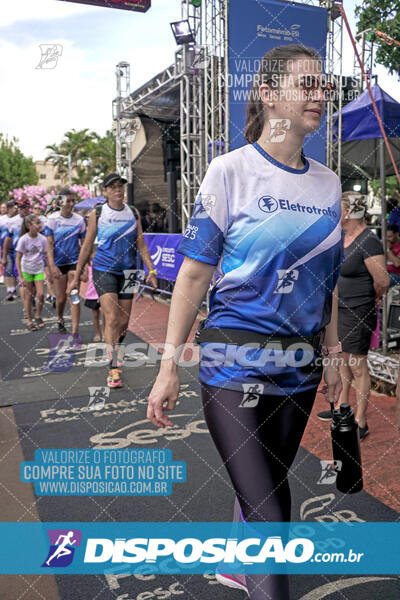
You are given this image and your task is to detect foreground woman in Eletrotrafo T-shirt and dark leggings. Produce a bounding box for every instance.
[147,45,343,600]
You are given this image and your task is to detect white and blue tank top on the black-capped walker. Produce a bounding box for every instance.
[93,202,137,275]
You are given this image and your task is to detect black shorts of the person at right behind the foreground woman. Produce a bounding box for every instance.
[338,301,377,355]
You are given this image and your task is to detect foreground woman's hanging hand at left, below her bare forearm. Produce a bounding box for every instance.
[147,371,180,427]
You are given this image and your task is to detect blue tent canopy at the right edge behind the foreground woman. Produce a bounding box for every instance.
[333,84,400,179]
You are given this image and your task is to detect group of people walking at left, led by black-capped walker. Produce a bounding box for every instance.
[0,173,157,388]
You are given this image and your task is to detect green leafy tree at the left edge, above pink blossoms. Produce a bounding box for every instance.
[0,133,39,202]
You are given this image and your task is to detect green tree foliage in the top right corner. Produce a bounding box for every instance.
[355,0,400,75]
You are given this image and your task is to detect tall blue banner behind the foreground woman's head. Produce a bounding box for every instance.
[228,0,328,163]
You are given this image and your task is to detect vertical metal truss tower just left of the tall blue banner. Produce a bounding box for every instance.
[181,0,229,231]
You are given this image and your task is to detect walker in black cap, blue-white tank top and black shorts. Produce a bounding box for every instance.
[68,173,157,388]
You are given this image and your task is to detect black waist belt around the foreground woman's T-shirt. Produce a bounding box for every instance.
[194,319,325,350]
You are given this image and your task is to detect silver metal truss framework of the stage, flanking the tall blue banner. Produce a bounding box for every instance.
[114,0,343,231]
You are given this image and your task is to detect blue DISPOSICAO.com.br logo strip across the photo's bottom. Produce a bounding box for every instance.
[0,522,400,575]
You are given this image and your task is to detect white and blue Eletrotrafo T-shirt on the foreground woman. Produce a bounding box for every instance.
[178,143,343,395]
